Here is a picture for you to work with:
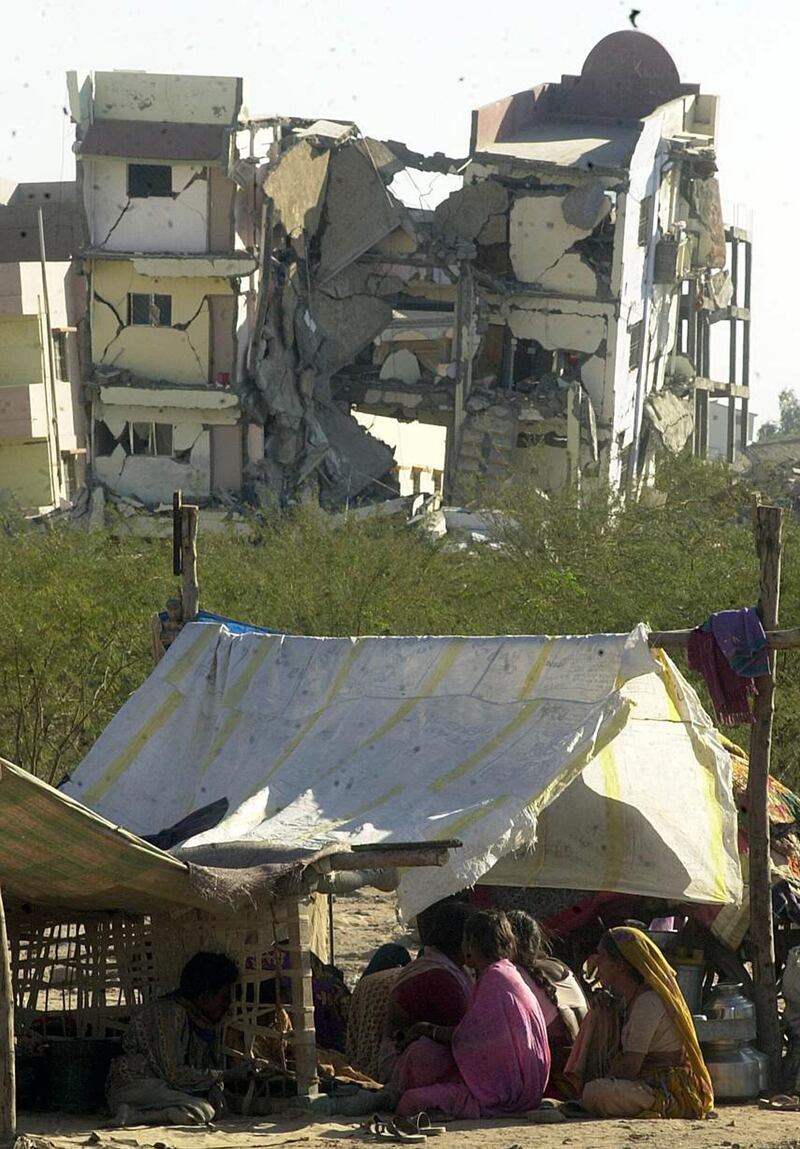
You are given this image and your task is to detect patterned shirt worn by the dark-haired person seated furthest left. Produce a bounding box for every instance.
[107,995,222,1094]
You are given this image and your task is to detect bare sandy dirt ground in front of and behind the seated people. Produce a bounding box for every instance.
[17,890,800,1149]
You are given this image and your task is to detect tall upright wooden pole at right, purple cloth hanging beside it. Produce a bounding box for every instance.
[747,507,783,1088]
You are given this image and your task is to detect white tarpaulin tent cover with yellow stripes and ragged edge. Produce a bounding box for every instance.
[63,624,741,913]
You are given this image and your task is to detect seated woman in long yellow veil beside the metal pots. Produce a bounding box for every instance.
[564,926,714,1119]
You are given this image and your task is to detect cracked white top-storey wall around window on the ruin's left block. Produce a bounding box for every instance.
[82,159,209,253]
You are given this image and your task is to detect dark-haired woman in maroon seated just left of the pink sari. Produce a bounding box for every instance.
[377,900,474,1081]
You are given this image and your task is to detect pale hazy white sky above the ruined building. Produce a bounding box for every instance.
[0,0,800,418]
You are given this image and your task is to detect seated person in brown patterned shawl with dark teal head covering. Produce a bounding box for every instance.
[345,942,411,1080]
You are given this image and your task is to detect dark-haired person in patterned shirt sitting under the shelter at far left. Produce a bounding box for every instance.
[106,951,240,1125]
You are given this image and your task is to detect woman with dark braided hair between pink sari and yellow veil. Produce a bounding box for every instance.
[508,910,589,1096]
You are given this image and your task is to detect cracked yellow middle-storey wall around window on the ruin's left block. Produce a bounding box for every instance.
[92,260,232,385]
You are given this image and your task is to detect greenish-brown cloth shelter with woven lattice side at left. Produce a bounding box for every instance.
[0,758,447,1096]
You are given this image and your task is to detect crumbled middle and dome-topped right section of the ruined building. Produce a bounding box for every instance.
[247,32,749,501]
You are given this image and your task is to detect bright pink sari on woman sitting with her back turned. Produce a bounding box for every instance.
[398,958,549,1119]
